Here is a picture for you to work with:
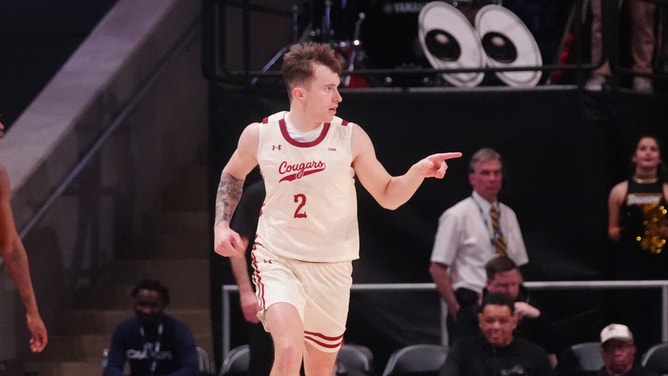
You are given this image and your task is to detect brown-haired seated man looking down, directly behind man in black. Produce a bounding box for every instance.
[483,256,560,368]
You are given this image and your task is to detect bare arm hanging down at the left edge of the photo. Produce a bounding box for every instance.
[0,165,48,352]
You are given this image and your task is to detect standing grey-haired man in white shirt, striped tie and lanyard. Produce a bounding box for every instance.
[429,148,529,344]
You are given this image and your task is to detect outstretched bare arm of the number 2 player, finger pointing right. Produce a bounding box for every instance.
[352,126,462,210]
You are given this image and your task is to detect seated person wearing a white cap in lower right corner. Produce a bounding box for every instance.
[598,324,658,376]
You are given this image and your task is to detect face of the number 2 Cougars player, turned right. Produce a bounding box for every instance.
[305,65,343,122]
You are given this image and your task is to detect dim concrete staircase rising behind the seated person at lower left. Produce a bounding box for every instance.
[30,153,214,376]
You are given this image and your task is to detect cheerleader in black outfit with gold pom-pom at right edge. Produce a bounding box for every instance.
[608,136,668,351]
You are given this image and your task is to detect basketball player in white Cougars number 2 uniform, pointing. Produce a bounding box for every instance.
[214,42,461,376]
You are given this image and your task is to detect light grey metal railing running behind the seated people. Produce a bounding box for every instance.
[222,280,668,357]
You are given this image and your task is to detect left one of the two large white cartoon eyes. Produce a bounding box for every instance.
[418,1,485,87]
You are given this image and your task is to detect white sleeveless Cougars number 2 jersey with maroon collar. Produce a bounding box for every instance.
[256,112,359,262]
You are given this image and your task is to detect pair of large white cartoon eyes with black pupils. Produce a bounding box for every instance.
[418,1,543,87]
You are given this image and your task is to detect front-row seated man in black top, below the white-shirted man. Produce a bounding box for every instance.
[440,293,553,376]
